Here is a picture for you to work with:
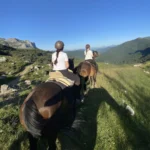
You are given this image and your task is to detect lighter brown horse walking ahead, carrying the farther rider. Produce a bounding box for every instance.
[74,51,99,95]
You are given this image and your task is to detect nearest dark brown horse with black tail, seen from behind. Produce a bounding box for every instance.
[19,59,74,150]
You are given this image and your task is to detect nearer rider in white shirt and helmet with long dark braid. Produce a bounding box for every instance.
[52,41,80,118]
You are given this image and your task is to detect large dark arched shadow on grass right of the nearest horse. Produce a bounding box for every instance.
[9,84,150,150]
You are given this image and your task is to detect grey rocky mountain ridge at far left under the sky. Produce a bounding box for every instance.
[0,38,37,49]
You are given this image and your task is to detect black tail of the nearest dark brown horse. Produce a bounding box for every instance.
[23,98,46,137]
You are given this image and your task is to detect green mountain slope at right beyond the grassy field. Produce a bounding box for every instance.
[97,37,150,64]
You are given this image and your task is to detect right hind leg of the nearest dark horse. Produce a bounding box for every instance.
[48,131,57,150]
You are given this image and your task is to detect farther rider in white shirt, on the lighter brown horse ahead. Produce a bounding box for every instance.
[84,44,98,71]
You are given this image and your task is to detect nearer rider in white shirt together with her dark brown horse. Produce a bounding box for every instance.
[19,41,84,150]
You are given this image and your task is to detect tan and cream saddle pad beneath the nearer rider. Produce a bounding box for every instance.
[46,71,74,89]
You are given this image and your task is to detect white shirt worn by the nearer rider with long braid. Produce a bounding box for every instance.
[52,51,68,70]
